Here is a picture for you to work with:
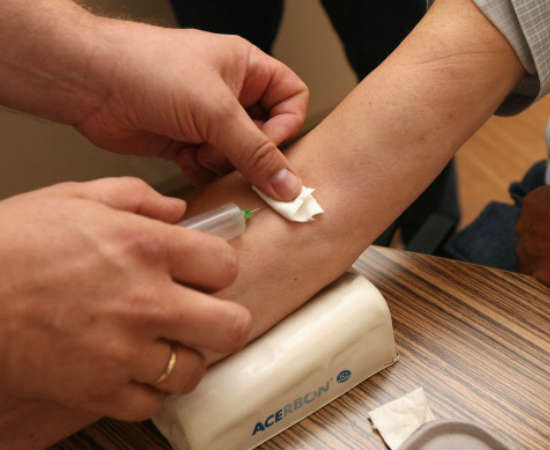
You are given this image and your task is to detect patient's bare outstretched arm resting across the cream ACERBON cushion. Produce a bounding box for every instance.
[0,0,523,446]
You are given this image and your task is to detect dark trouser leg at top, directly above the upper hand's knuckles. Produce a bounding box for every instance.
[171,0,283,53]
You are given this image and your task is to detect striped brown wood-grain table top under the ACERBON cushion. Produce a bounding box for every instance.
[53,247,550,449]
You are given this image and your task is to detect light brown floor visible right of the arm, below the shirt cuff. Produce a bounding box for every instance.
[456,96,550,227]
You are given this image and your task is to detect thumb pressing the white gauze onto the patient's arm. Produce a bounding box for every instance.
[212,98,302,201]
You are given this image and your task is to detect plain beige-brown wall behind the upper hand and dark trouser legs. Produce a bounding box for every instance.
[0,0,355,198]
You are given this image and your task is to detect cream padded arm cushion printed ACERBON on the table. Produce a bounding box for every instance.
[154,274,397,449]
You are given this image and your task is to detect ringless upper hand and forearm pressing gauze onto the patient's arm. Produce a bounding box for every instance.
[0,0,309,200]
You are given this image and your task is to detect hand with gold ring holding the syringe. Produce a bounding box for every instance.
[0,178,254,420]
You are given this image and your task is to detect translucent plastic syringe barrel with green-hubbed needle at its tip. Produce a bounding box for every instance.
[178,203,246,240]
